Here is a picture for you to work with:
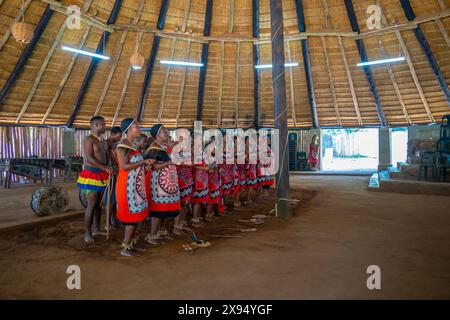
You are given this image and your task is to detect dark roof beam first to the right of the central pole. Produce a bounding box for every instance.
[295,0,319,128]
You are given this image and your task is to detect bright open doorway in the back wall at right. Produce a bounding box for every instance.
[321,128,378,171]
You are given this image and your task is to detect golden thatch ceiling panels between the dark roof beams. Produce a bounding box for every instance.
[0,0,450,128]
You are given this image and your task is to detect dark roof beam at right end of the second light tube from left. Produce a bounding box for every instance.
[196,0,213,121]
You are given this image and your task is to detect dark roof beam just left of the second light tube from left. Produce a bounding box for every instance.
[136,0,169,121]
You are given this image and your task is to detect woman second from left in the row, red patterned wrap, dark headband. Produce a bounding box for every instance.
[145,124,181,244]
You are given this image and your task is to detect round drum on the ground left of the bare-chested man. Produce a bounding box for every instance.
[30,185,69,217]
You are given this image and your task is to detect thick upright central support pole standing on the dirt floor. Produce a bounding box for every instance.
[270,0,292,218]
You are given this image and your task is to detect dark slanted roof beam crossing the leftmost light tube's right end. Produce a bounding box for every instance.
[66,0,122,128]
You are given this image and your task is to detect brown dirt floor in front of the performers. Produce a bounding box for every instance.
[0,176,450,299]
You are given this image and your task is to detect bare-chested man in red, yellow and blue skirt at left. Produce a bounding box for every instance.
[77,116,113,243]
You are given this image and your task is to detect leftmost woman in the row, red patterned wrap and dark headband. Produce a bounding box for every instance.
[116,118,154,257]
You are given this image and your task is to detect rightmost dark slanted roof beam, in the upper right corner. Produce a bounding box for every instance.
[400,0,450,107]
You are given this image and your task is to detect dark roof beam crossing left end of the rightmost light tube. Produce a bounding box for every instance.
[344,0,388,127]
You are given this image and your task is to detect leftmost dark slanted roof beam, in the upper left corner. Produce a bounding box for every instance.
[0,6,53,111]
